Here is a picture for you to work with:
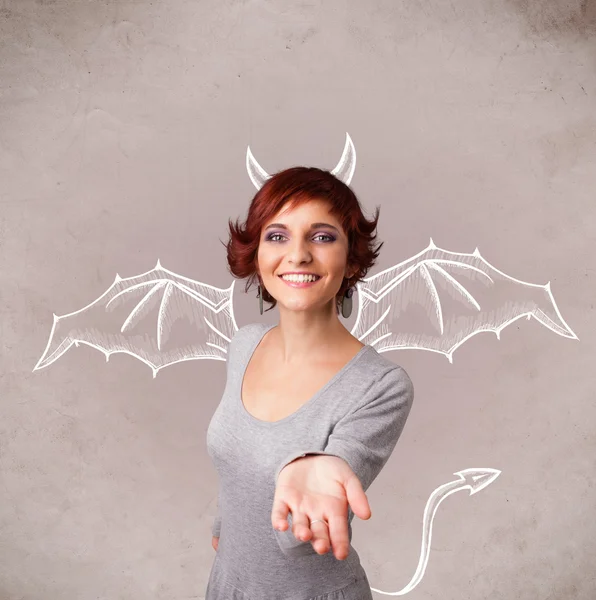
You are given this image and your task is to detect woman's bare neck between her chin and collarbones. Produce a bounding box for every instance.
[272,303,353,364]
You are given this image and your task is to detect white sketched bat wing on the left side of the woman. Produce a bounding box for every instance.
[33,260,238,377]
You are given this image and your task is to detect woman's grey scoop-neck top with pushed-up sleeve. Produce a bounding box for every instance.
[206,323,413,600]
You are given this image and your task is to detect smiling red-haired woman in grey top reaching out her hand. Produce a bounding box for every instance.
[206,167,413,600]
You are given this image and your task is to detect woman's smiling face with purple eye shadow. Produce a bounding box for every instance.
[257,200,355,311]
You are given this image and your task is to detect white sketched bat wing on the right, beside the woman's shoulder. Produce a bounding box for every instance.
[351,239,578,362]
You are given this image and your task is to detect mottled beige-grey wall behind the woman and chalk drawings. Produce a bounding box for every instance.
[0,0,596,600]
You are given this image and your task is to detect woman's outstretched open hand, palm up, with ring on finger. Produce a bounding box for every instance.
[271,454,371,560]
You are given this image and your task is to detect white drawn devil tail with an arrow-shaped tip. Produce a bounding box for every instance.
[370,468,501,596]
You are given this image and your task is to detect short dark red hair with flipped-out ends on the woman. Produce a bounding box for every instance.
[225,167,383,310]
